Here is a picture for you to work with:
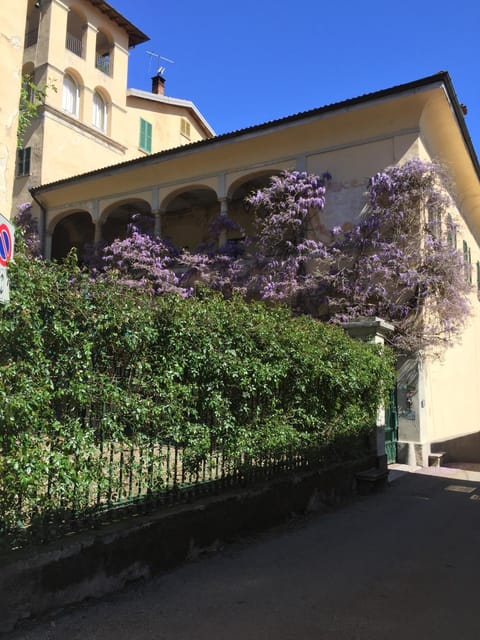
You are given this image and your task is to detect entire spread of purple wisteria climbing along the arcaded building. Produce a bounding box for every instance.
[18,159,470,353]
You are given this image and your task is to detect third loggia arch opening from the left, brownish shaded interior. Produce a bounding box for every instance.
[161,185,220,251]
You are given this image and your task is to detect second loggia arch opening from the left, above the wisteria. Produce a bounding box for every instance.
[100,198,154,242]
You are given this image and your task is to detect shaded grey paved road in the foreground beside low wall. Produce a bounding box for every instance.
[9,464,480,640]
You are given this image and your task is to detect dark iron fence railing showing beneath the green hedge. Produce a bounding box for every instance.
[0,438,366,549]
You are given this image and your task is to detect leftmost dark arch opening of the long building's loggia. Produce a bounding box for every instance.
[48,210,95,262]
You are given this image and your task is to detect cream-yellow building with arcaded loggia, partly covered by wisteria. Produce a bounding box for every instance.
[32,72,480,465]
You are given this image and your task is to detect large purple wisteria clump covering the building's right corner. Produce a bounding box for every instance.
[320,160,470,353]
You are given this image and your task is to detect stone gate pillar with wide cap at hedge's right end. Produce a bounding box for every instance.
[342,317,394,471]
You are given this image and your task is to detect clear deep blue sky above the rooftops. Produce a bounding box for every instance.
[110,0,480,155]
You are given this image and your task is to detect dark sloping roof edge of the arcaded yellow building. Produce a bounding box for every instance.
[30,71,480,195]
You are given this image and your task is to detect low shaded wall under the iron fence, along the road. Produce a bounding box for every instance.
[0,458,375,633]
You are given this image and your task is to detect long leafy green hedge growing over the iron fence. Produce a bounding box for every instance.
[0,255,393,536]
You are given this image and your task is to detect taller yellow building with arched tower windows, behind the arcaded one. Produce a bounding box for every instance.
[14,0,214,215]
